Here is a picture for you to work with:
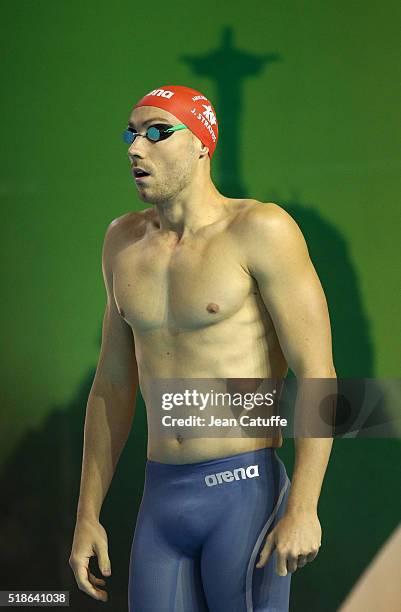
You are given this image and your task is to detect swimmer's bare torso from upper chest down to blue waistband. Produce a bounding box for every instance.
[119,210,288,464]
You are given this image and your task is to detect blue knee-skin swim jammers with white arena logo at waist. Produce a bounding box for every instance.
[128,448,291,612]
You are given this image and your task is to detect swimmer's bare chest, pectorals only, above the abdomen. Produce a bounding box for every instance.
[113,228,254,331]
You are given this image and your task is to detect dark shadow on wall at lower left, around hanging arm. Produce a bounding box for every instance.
[0,371,146,612]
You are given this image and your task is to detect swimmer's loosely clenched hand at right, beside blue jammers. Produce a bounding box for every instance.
[256,510,322,576]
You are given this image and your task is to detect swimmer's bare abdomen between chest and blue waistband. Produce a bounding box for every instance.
[136,328,287,464]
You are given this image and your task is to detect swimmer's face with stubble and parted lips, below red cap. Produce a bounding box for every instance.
[128,106,199,204]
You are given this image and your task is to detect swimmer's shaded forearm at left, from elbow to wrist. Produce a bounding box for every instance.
[77,380,136,519]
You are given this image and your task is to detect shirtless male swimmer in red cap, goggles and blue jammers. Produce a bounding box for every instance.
[70,86,336,612]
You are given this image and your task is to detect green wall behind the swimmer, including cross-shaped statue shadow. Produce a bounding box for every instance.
[0,0,401,610]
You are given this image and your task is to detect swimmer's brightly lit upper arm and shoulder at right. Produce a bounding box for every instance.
[246,204,334,378]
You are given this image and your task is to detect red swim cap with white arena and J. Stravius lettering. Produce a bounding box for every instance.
[134,85,219,159]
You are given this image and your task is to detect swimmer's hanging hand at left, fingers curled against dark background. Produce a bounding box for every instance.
[69,518,111,601]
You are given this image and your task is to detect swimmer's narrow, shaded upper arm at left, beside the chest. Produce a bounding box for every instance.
[95,220,138,390]
